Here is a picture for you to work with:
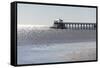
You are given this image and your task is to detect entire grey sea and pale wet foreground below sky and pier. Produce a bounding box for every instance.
[17,25,96,64]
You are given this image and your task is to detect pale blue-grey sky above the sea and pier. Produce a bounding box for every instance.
[17,3,96,26]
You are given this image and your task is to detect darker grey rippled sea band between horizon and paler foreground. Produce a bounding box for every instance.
[17,25,96,45]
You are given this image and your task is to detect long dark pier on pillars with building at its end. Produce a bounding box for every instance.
[52,19,96,30]
